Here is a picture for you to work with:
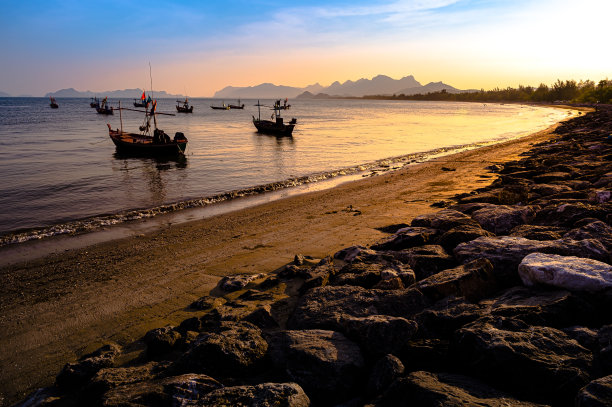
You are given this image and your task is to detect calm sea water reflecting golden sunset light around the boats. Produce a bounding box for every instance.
[0,98,568,245]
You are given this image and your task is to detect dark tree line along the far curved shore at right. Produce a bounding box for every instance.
[364,79,612,104]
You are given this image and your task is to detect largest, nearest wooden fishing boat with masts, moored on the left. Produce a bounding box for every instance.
[106,100,187,157]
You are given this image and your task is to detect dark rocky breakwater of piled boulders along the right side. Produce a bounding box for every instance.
[16,111,612,407]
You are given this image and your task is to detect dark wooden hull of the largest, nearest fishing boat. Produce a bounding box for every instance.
[108,125,187,157]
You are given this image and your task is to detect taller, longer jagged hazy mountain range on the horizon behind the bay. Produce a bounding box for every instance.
[214,75,476,99]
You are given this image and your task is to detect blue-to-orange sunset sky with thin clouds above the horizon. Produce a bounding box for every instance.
[0,0,612,97]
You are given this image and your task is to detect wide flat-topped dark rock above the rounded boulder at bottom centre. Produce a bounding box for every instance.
[287,286,430,332]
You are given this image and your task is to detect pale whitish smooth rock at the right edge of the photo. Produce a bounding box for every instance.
[518,253,612,291]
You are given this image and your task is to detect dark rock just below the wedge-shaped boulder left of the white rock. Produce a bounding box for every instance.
[414,297,487,338]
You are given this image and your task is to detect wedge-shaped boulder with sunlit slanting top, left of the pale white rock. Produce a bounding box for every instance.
[416,259,499,301]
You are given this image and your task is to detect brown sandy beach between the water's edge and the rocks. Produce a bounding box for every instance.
[0,118,572,404]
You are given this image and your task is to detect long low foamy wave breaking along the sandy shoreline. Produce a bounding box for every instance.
[0,139,492,247]
